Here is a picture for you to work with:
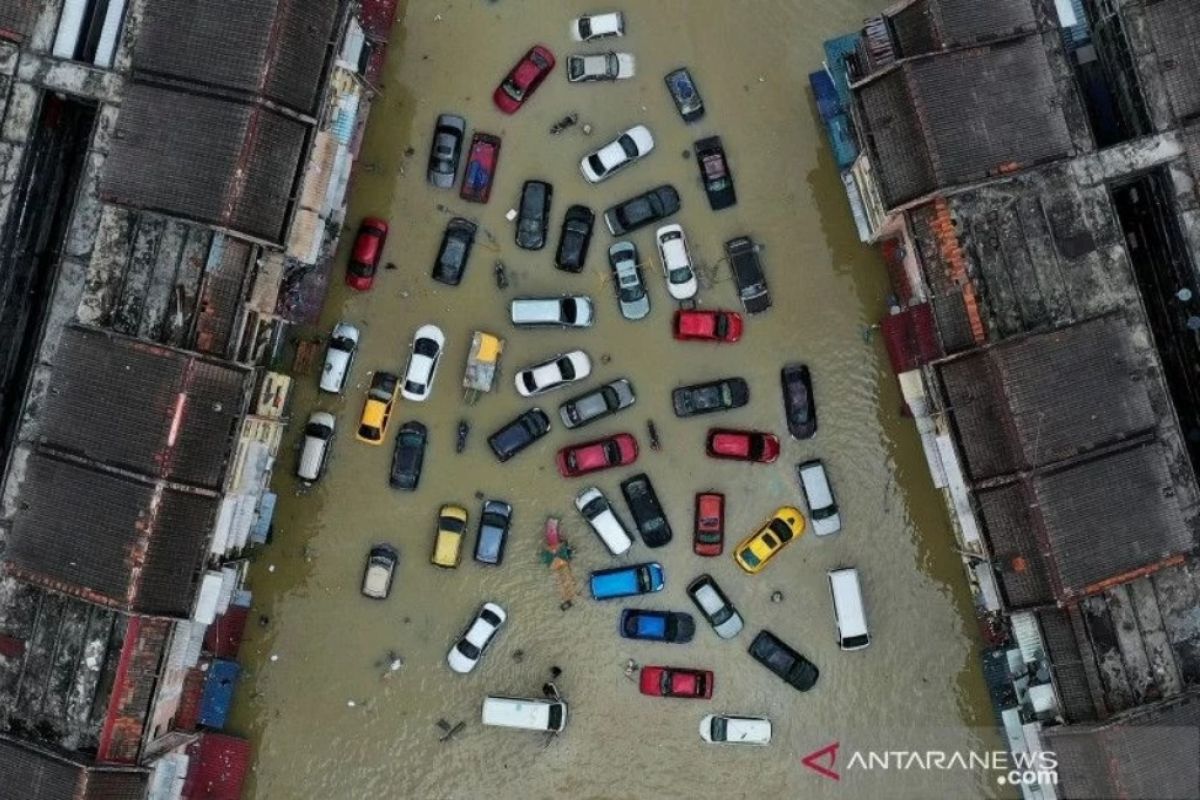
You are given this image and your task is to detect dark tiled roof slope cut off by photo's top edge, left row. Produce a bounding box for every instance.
[133,0,341,115]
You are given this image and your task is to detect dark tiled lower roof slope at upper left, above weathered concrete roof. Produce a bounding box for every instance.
[101,83,310,243]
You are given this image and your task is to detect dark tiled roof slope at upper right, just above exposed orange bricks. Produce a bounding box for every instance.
[854,36,1073,207]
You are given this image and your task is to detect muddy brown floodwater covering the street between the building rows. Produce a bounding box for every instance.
[232,0,996,800]
